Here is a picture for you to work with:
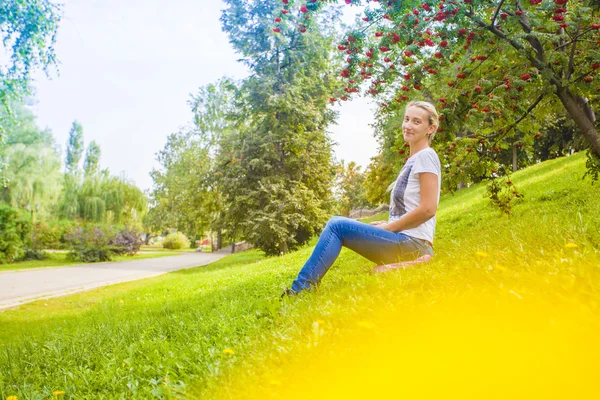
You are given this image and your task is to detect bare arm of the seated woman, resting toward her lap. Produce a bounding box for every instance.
[379,172,439,232]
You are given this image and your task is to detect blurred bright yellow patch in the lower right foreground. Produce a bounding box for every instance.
[223,289,600,399]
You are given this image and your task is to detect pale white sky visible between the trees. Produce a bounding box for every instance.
[29,0,377,189]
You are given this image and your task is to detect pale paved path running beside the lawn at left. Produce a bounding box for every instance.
[0,249,230,310]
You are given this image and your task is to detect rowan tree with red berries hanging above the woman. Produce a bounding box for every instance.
[282,0,600,188]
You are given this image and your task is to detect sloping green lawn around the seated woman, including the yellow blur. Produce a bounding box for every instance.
[0,154,600,399]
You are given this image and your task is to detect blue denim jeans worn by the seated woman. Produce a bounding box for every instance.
[292,217,433,292]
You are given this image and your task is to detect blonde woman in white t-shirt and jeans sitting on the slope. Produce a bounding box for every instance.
[284,101,441,295]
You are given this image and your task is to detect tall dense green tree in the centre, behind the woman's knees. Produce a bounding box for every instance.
[215,0,338,254]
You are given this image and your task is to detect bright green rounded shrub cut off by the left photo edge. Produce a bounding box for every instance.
[0,204,31,264]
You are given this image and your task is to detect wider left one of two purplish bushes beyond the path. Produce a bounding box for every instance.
[66,227,114,262]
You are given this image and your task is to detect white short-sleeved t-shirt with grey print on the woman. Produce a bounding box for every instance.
[389,147,442,243]
